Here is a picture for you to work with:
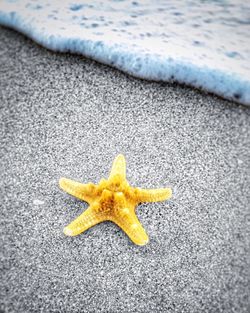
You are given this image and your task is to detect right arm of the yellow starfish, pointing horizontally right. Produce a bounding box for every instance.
[134,188,172,203]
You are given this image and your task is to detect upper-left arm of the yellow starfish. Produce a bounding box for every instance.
[59,178,96,202]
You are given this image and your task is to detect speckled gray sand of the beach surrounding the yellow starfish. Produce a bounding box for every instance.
[0,28,250,313]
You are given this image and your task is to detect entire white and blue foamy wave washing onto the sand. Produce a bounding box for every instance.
[0,0,250,105]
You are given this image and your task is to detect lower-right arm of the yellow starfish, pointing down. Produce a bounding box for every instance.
[113,208,149,246]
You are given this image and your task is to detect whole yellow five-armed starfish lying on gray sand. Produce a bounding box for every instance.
[59,154,172,246]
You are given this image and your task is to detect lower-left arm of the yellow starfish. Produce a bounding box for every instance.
[63,206,107,236]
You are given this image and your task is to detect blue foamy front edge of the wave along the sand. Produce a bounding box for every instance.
[0,12,250,107]
